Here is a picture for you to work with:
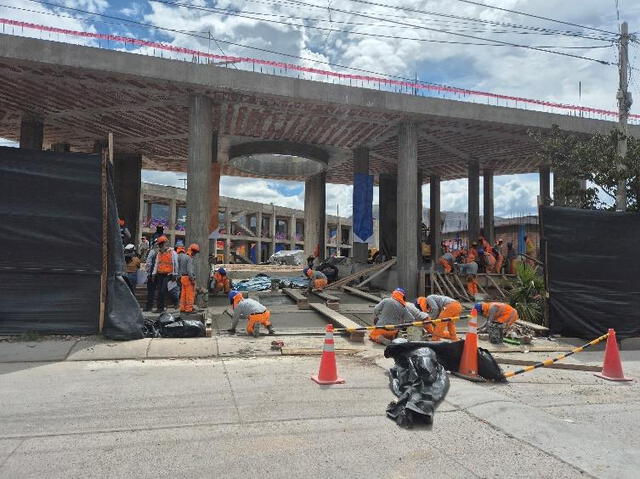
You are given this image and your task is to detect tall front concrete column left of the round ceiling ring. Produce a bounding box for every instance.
[185,95,214,288]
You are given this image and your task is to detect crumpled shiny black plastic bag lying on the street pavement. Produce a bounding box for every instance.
[385,347,449,428]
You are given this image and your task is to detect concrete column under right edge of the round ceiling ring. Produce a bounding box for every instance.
[304,173,327,260]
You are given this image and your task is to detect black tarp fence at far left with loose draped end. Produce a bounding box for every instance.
[0,147,142,339]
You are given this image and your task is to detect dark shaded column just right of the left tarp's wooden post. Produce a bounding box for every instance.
[113,153,142,241]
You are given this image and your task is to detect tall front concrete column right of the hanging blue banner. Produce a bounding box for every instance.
[396,122,419,299]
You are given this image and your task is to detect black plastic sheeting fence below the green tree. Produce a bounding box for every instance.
[541,207,640,339]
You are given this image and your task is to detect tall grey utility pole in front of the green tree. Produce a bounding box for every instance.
[616,22,632,211]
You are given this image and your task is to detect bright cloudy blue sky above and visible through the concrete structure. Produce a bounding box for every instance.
[0,0,640,216]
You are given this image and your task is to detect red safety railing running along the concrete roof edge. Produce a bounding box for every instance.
[0,18,640,119]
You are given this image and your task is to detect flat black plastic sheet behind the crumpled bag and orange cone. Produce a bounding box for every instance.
[384,341,506,382]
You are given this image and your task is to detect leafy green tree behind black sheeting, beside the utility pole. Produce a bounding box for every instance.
[532,125,640,211]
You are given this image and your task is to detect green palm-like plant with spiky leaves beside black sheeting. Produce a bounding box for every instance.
[509,263,545,324]
